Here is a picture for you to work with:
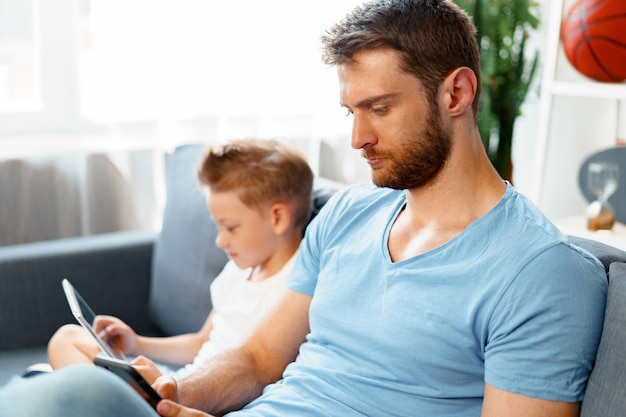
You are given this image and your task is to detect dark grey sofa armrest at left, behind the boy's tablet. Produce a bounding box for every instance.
[0,231,156,350]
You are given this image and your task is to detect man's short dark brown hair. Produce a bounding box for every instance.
[322,0,481,119]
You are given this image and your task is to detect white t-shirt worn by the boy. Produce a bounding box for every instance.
[173,252,297,378]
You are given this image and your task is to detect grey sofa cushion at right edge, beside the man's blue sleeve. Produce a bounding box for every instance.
[580,262,626,417]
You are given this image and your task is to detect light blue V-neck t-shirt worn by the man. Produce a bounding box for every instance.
[237,185,607,417]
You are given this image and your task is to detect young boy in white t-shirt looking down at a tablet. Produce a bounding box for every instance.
[48,139,313,382]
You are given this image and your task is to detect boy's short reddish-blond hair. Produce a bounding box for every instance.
[198,139,313,226]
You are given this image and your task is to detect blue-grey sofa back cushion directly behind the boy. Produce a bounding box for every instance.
[149,144,343,335]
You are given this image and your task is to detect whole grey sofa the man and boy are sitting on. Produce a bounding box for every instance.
[0,145,626,417]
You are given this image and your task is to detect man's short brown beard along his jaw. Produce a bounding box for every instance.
[364,104,451,190]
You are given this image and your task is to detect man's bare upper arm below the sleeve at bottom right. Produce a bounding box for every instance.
[481,384,580,417]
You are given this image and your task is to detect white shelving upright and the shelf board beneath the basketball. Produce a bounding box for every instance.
[530,0,626,207]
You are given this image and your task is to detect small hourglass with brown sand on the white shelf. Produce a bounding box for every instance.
[587,162,619,230]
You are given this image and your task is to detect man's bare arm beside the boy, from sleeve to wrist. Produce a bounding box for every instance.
[168,289,311,415]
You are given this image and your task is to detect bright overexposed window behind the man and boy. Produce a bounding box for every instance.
[0,0,360,141]
